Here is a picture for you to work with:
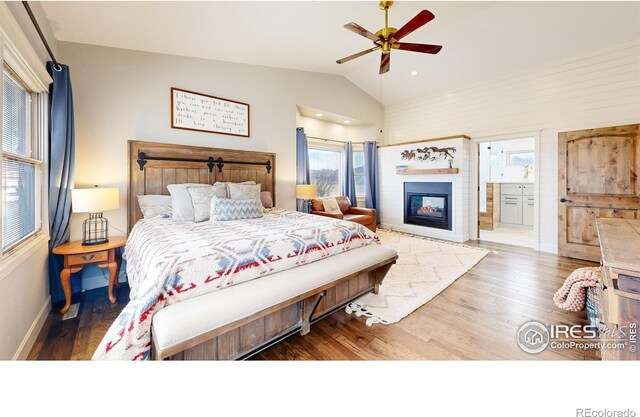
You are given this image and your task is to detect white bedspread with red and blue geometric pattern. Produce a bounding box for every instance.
[93,209,379,360]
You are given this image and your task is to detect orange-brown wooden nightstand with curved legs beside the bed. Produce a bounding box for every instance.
[53,236,127,314]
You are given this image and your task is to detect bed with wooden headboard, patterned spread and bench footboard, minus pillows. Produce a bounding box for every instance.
[94,141,397,360]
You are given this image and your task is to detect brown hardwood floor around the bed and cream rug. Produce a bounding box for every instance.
[28,242,599,360]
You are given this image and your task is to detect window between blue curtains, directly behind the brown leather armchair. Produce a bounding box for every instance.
[309,148,342,197]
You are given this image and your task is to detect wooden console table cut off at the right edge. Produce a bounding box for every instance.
[596,218,640,360]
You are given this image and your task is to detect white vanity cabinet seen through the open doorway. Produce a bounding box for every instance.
[500,183,534,226]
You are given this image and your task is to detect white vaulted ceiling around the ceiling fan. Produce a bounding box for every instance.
[42,1,640,104]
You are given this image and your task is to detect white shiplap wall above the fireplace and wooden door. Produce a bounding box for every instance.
[381,41,640,253]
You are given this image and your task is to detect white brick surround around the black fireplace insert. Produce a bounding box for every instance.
[378,137,470,242]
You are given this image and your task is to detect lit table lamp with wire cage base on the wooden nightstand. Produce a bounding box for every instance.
[71,185,120,245]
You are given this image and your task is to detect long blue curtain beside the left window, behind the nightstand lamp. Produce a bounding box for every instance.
[47,61,75,303]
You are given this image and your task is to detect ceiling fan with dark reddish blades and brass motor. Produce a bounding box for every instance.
[336,1,442,74]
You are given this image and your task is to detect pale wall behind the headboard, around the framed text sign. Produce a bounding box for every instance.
[59,42,382,288]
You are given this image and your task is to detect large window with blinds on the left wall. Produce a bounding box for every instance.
[1,62,41,252]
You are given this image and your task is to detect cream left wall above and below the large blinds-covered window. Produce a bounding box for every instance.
[0,2,57,360]
